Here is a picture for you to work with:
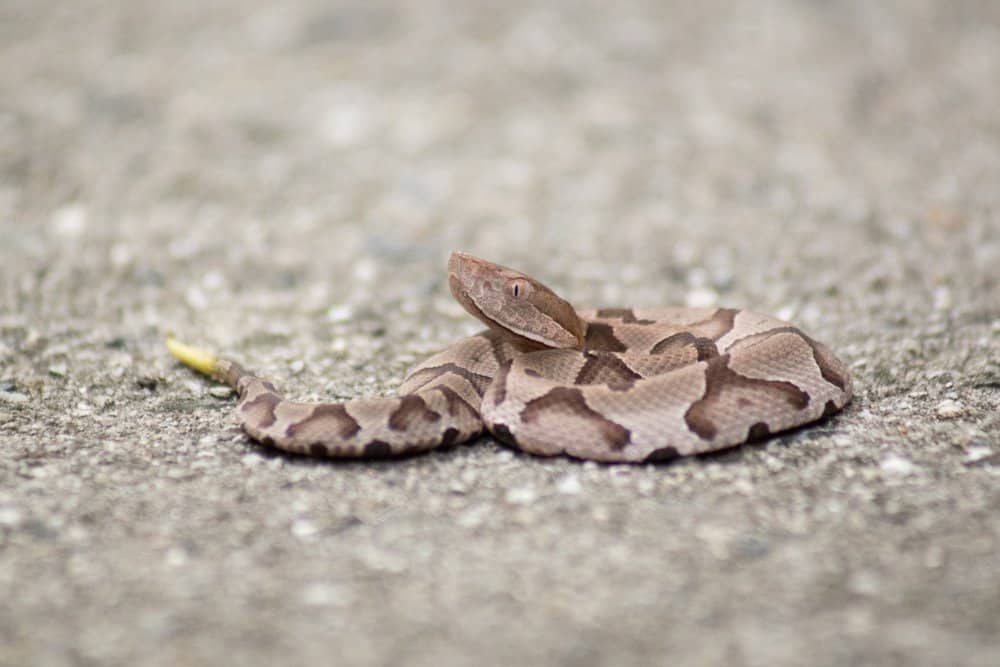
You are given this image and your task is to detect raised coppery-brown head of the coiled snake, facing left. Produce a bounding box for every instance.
[448,252,586,349]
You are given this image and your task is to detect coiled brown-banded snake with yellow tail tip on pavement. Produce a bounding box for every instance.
[167,252,851,463]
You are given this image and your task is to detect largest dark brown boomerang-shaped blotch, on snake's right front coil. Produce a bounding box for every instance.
[684,354,809,440]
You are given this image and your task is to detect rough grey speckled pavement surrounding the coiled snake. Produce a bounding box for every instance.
[0,0,1000,665]
